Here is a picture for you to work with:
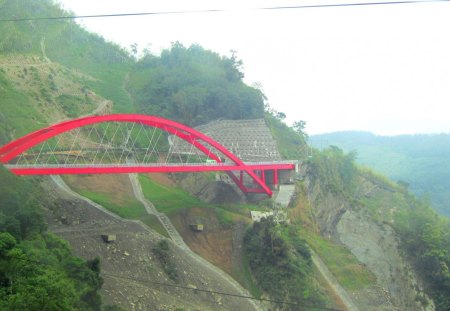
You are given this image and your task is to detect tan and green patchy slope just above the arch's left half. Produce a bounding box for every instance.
[0,54,111,144]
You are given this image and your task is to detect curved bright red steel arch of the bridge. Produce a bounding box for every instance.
[0,114,272,196]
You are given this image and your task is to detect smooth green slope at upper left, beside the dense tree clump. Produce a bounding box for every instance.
[0,0,134,112]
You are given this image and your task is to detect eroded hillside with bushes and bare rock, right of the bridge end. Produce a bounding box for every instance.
[300,148,449,310]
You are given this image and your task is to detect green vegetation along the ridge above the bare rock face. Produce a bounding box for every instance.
[308,147,450,310]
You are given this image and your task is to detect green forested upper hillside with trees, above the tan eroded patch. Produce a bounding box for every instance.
[0,0,270,135]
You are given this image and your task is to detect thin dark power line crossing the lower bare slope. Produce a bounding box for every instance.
[101,273,342,311]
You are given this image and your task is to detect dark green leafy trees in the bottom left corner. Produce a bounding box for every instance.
[0,168,103,311]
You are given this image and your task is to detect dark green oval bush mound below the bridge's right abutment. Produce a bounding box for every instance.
[244,218,324,310]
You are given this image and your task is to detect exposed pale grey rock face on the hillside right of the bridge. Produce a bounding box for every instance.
[305,172,434,310]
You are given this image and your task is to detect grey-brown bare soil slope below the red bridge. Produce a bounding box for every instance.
[47,178,260,310]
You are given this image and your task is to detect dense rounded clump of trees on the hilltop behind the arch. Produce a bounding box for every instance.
[129,42,264,126]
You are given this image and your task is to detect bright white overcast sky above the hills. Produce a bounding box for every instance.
[58,0,450,135]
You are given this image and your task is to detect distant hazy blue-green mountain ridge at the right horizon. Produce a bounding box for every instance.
[311,131,450,217]
